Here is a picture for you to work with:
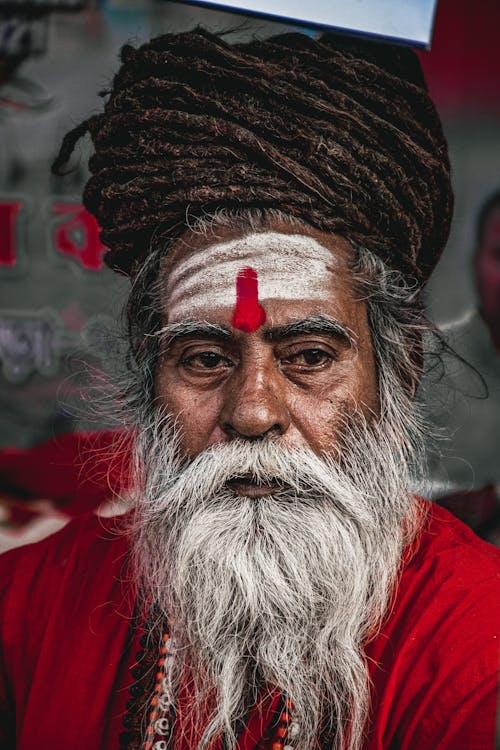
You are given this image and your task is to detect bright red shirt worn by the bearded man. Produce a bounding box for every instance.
[0,506,500,750]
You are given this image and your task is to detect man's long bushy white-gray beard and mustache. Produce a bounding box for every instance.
[129,416,419,750]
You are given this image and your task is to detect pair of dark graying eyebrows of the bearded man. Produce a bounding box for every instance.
[152,315,356,346]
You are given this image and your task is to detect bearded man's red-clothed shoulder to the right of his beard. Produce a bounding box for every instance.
[367,504,500,750]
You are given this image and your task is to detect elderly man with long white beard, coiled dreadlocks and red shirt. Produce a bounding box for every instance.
[1,30,500,750]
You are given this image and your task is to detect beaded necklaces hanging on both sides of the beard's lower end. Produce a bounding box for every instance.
[120,623,298,750]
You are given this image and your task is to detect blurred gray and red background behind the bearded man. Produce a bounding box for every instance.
[0,0,500,550]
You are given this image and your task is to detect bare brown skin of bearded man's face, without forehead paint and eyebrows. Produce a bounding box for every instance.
[155,220,378,495]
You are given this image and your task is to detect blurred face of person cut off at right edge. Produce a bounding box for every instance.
[476,206,500,351]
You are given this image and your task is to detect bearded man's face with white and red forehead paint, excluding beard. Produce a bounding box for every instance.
[156,220,378,476]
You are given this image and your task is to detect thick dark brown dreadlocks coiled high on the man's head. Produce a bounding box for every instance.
[54,29,453,281]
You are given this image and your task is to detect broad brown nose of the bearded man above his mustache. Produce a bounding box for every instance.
[219,362,290,440]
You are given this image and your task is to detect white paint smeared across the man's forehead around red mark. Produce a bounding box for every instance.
[167,232,335,321]
